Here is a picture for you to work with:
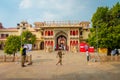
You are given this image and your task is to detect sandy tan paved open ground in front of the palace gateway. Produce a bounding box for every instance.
[0,51,120,80]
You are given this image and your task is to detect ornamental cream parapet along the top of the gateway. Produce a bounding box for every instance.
[34,21,90,28]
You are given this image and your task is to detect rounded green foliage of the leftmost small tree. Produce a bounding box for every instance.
[4,35,20,54]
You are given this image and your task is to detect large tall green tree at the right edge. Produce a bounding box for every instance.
[88,3,120,54]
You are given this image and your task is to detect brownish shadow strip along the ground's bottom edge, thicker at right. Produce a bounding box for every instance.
[3,71,120,80]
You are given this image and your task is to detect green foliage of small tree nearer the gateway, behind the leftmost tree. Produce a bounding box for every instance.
[21,31,36,44]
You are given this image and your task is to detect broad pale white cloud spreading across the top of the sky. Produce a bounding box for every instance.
[19,0,86,21]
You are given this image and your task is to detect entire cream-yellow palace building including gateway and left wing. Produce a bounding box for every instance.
[0,21,90,52]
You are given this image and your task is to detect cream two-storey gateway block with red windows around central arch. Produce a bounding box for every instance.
[35,21,89,52]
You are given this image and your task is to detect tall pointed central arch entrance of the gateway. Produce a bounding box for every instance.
[55,31,67,50]
